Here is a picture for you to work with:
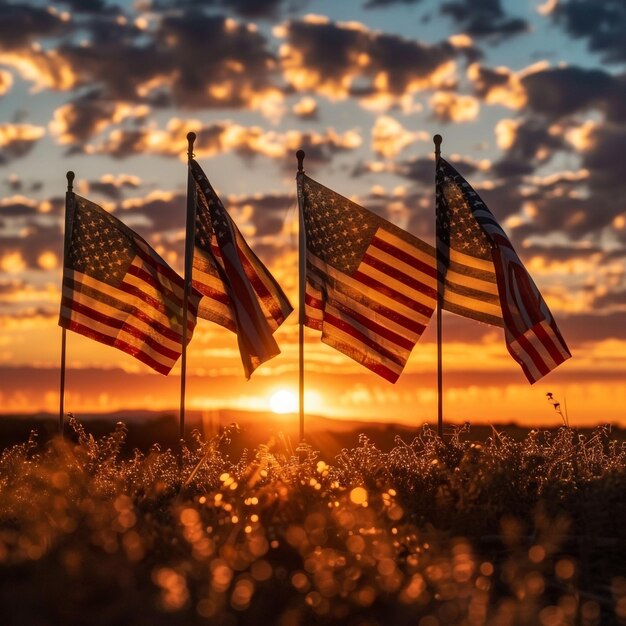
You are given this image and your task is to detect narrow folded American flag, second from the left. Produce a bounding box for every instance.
[189,159,293,378]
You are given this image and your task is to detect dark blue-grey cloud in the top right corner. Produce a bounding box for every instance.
[552,0,626,63]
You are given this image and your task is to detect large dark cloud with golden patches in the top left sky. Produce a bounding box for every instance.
[0,9,283,110]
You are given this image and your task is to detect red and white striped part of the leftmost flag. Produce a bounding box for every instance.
[60,252,197,375]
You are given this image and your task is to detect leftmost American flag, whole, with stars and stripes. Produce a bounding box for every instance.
[59,195,198,375]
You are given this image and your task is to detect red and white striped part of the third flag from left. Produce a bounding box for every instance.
[305,227,437,383]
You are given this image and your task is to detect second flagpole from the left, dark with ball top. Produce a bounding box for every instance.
[179,133,196,441]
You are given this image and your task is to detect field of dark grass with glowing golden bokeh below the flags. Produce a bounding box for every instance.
[0,419,626,626]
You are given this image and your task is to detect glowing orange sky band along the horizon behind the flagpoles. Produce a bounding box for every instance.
[0,302,626,426]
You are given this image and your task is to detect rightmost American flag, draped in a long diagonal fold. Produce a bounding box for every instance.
[436,159,571,383]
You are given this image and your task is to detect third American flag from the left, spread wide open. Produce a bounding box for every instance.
[301,175,437,383]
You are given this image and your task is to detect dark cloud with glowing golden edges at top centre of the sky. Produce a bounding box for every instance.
[274,15,457,100]
